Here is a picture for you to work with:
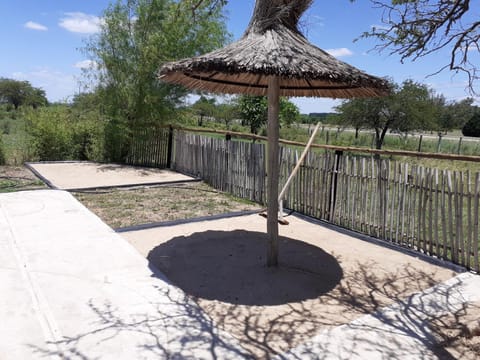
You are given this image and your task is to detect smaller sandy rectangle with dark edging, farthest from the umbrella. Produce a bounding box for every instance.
[28,162,193,190]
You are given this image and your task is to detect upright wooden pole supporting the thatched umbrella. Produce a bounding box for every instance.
[267,76,280,267]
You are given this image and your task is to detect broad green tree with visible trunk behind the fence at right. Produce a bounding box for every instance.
[336,80,436,149]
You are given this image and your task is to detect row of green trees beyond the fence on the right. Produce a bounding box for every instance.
[309,80,480,149]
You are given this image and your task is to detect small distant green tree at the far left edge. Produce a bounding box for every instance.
[0,78,48,110]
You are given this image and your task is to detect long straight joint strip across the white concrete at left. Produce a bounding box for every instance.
[0,203,61,359]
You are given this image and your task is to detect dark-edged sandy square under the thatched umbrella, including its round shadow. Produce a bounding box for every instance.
[122,215,456,359]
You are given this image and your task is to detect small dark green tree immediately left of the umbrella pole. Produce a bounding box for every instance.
[238,95,268,134]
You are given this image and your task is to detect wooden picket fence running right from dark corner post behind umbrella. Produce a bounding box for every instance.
[172,131,480,272]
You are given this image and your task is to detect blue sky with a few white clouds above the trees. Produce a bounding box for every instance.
[0,0,480,113]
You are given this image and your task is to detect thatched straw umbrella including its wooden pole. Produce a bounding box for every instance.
[159,0,389,266]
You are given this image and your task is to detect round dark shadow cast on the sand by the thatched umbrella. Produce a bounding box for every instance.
[148,230,343,306]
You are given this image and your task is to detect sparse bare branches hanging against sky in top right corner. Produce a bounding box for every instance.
[360,0,480,92]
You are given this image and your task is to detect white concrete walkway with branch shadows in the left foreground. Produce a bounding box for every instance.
[0,190,249,360]
